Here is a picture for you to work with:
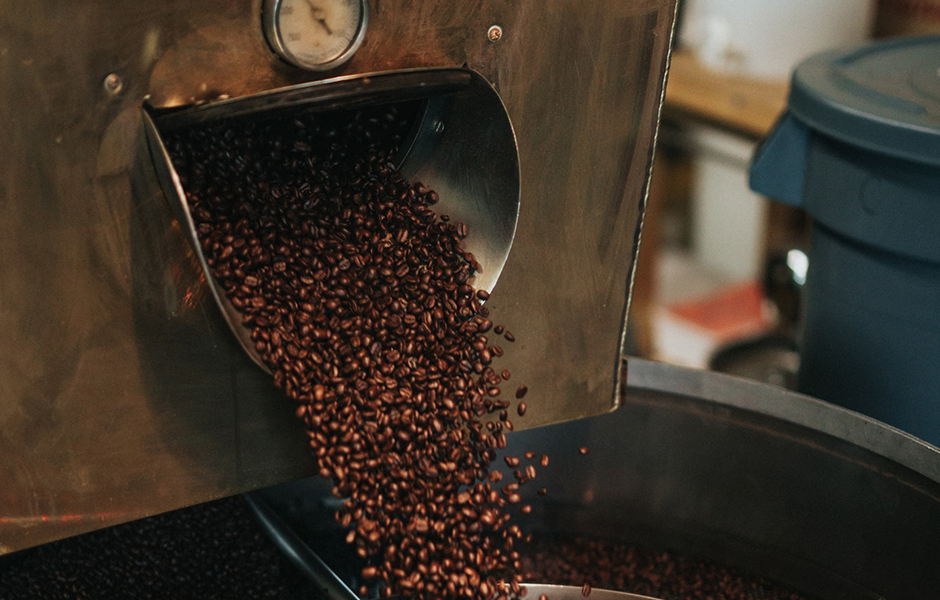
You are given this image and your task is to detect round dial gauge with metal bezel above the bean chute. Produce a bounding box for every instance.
[262,0,369,71]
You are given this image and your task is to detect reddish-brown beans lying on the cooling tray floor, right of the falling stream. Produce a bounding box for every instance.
[522,537,808,600]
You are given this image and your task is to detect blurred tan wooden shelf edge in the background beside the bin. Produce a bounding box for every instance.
[663,50,790,138]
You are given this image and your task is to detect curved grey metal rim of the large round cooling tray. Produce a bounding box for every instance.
[624,357,940,483]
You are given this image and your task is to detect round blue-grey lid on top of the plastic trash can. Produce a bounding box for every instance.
[789,36,940,166]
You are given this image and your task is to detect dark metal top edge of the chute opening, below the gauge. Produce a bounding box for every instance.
[149,68,471,130]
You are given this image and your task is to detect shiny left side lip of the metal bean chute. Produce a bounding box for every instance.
[143,110,272,374]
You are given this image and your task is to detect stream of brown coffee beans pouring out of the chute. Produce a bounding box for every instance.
[167,107,547,599]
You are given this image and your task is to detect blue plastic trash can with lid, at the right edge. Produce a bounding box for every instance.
[750,37,940,445]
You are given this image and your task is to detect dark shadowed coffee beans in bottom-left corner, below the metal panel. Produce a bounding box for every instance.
[0,497,319,600]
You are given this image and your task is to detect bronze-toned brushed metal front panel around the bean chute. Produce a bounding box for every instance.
[0,0,675,554]
